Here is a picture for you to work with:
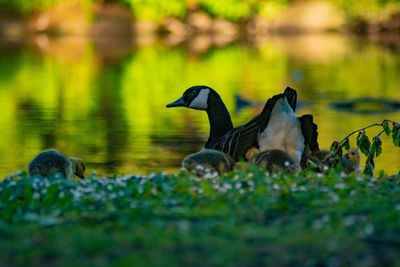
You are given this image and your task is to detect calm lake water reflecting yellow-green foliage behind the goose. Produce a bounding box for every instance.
[0,34,400,177]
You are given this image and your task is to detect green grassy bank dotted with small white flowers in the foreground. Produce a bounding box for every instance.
[0,167,400,266]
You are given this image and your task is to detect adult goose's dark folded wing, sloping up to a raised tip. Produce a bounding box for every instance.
[214,87,297,161]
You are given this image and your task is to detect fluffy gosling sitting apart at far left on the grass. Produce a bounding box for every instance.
[28,150,86,179]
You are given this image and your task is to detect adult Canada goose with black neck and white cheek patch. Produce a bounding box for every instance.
[167,85,318,163]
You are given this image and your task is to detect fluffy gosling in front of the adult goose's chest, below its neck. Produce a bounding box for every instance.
[182,149,235,175]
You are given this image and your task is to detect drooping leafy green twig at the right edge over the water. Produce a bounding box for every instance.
[331,120,400,175]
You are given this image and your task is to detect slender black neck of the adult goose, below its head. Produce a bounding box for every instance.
[205,94,233,148]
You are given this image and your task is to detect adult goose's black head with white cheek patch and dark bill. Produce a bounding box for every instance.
[167,85,217,110]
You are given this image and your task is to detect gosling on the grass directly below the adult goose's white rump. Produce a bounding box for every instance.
[246,148,301,174]
